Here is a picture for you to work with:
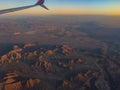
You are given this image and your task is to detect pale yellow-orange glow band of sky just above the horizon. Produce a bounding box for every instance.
[1,7,120,16]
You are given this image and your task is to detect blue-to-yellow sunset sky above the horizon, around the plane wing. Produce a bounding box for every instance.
[0,0,120,15]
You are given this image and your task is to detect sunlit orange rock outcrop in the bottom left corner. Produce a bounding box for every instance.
[0,71,40,90]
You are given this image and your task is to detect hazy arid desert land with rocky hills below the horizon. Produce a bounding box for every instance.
[0,16,120,90]
